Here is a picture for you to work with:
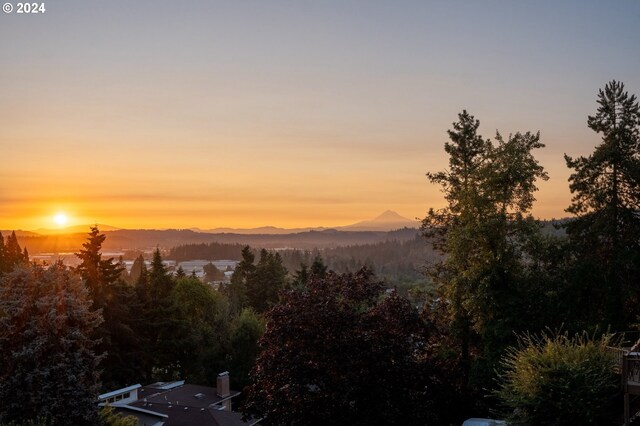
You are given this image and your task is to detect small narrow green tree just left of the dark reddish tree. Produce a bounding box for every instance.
[229,309,264,389]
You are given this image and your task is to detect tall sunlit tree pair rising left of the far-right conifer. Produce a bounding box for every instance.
[422,111,547,392]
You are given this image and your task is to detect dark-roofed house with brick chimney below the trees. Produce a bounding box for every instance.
[98,372,258,426]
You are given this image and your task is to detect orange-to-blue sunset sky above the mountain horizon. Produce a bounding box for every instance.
[0,0,640,233]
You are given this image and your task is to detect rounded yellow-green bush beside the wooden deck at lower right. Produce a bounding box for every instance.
[496,333,620,426]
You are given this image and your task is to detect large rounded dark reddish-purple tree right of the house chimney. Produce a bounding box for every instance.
[243,269,433,425]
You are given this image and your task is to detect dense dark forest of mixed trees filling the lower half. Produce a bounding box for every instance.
[0,81,640,425]
